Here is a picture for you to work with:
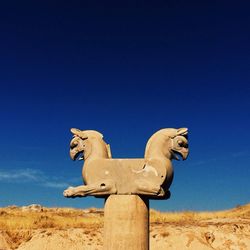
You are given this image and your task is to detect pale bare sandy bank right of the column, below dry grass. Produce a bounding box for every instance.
[150,220,250,250]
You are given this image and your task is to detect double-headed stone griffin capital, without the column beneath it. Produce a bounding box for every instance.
[64,128,188,199]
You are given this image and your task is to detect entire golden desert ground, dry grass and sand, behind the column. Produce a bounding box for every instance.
[0,204,250,250]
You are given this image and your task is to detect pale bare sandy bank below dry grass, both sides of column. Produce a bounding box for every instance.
[0,204,250,250]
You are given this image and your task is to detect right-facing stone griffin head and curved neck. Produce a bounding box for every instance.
[145,128,189,160]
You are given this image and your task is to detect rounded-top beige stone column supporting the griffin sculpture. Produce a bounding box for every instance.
[104,195,149,250]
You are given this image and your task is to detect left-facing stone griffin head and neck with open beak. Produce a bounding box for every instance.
[70,128,111,160]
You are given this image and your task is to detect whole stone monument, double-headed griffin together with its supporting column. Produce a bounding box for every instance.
[64,128,189,250]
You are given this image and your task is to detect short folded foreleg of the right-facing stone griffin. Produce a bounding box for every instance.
[133,180,165,196]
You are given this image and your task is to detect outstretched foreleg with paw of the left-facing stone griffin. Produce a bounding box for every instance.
[63,180,117,198]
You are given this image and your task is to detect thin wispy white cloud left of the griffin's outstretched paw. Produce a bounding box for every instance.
[0,168,73,189]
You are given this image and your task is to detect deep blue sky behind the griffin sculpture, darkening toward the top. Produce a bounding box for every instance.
[0,0,250,210]
